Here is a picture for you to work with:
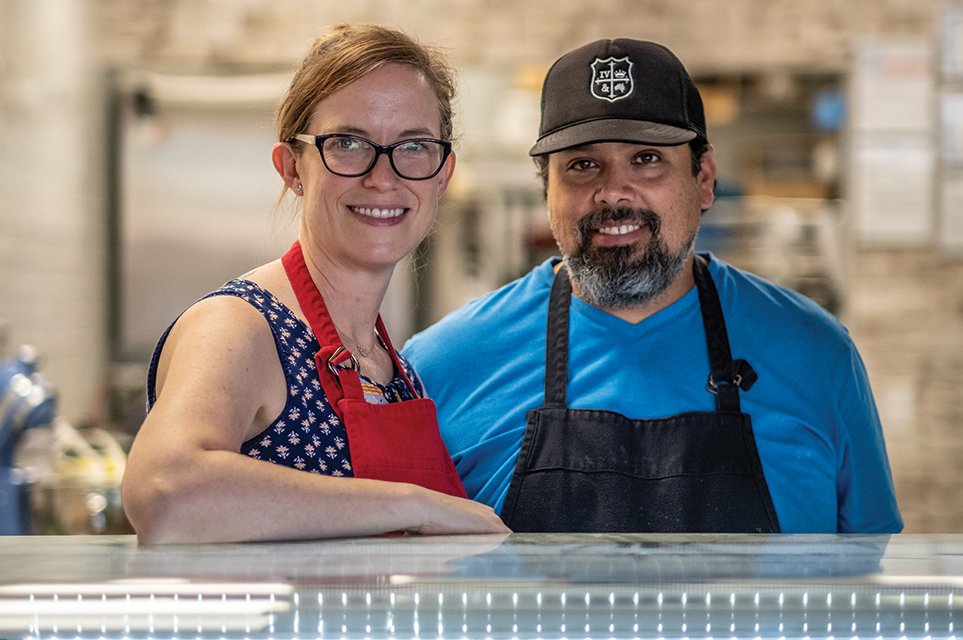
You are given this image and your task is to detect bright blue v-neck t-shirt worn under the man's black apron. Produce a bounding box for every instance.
[402,256,903,533]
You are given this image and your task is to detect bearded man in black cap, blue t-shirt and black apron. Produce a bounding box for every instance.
[404,39,902,532]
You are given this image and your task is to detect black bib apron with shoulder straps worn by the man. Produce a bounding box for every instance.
[501,256,779,533]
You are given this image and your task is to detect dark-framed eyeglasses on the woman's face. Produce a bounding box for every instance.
[288,133,451,180]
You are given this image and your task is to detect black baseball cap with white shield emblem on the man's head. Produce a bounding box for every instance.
[528,38,708,156]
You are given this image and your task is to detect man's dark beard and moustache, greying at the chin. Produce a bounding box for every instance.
[564,208,695,309]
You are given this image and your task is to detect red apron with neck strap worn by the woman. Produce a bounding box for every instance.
[281,241,467,498]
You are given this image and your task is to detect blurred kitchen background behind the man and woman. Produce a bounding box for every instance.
[0,0,963,533]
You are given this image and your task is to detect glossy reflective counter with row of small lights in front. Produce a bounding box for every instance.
[0,534,963,640]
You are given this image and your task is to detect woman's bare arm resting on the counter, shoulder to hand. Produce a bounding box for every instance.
[123,297,508,543]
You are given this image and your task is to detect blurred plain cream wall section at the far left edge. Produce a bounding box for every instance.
[0,0,106,420]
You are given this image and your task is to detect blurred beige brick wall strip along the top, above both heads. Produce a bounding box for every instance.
[92,0,949,72]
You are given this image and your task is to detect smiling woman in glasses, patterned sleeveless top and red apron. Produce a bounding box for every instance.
[123,26,507,543]
